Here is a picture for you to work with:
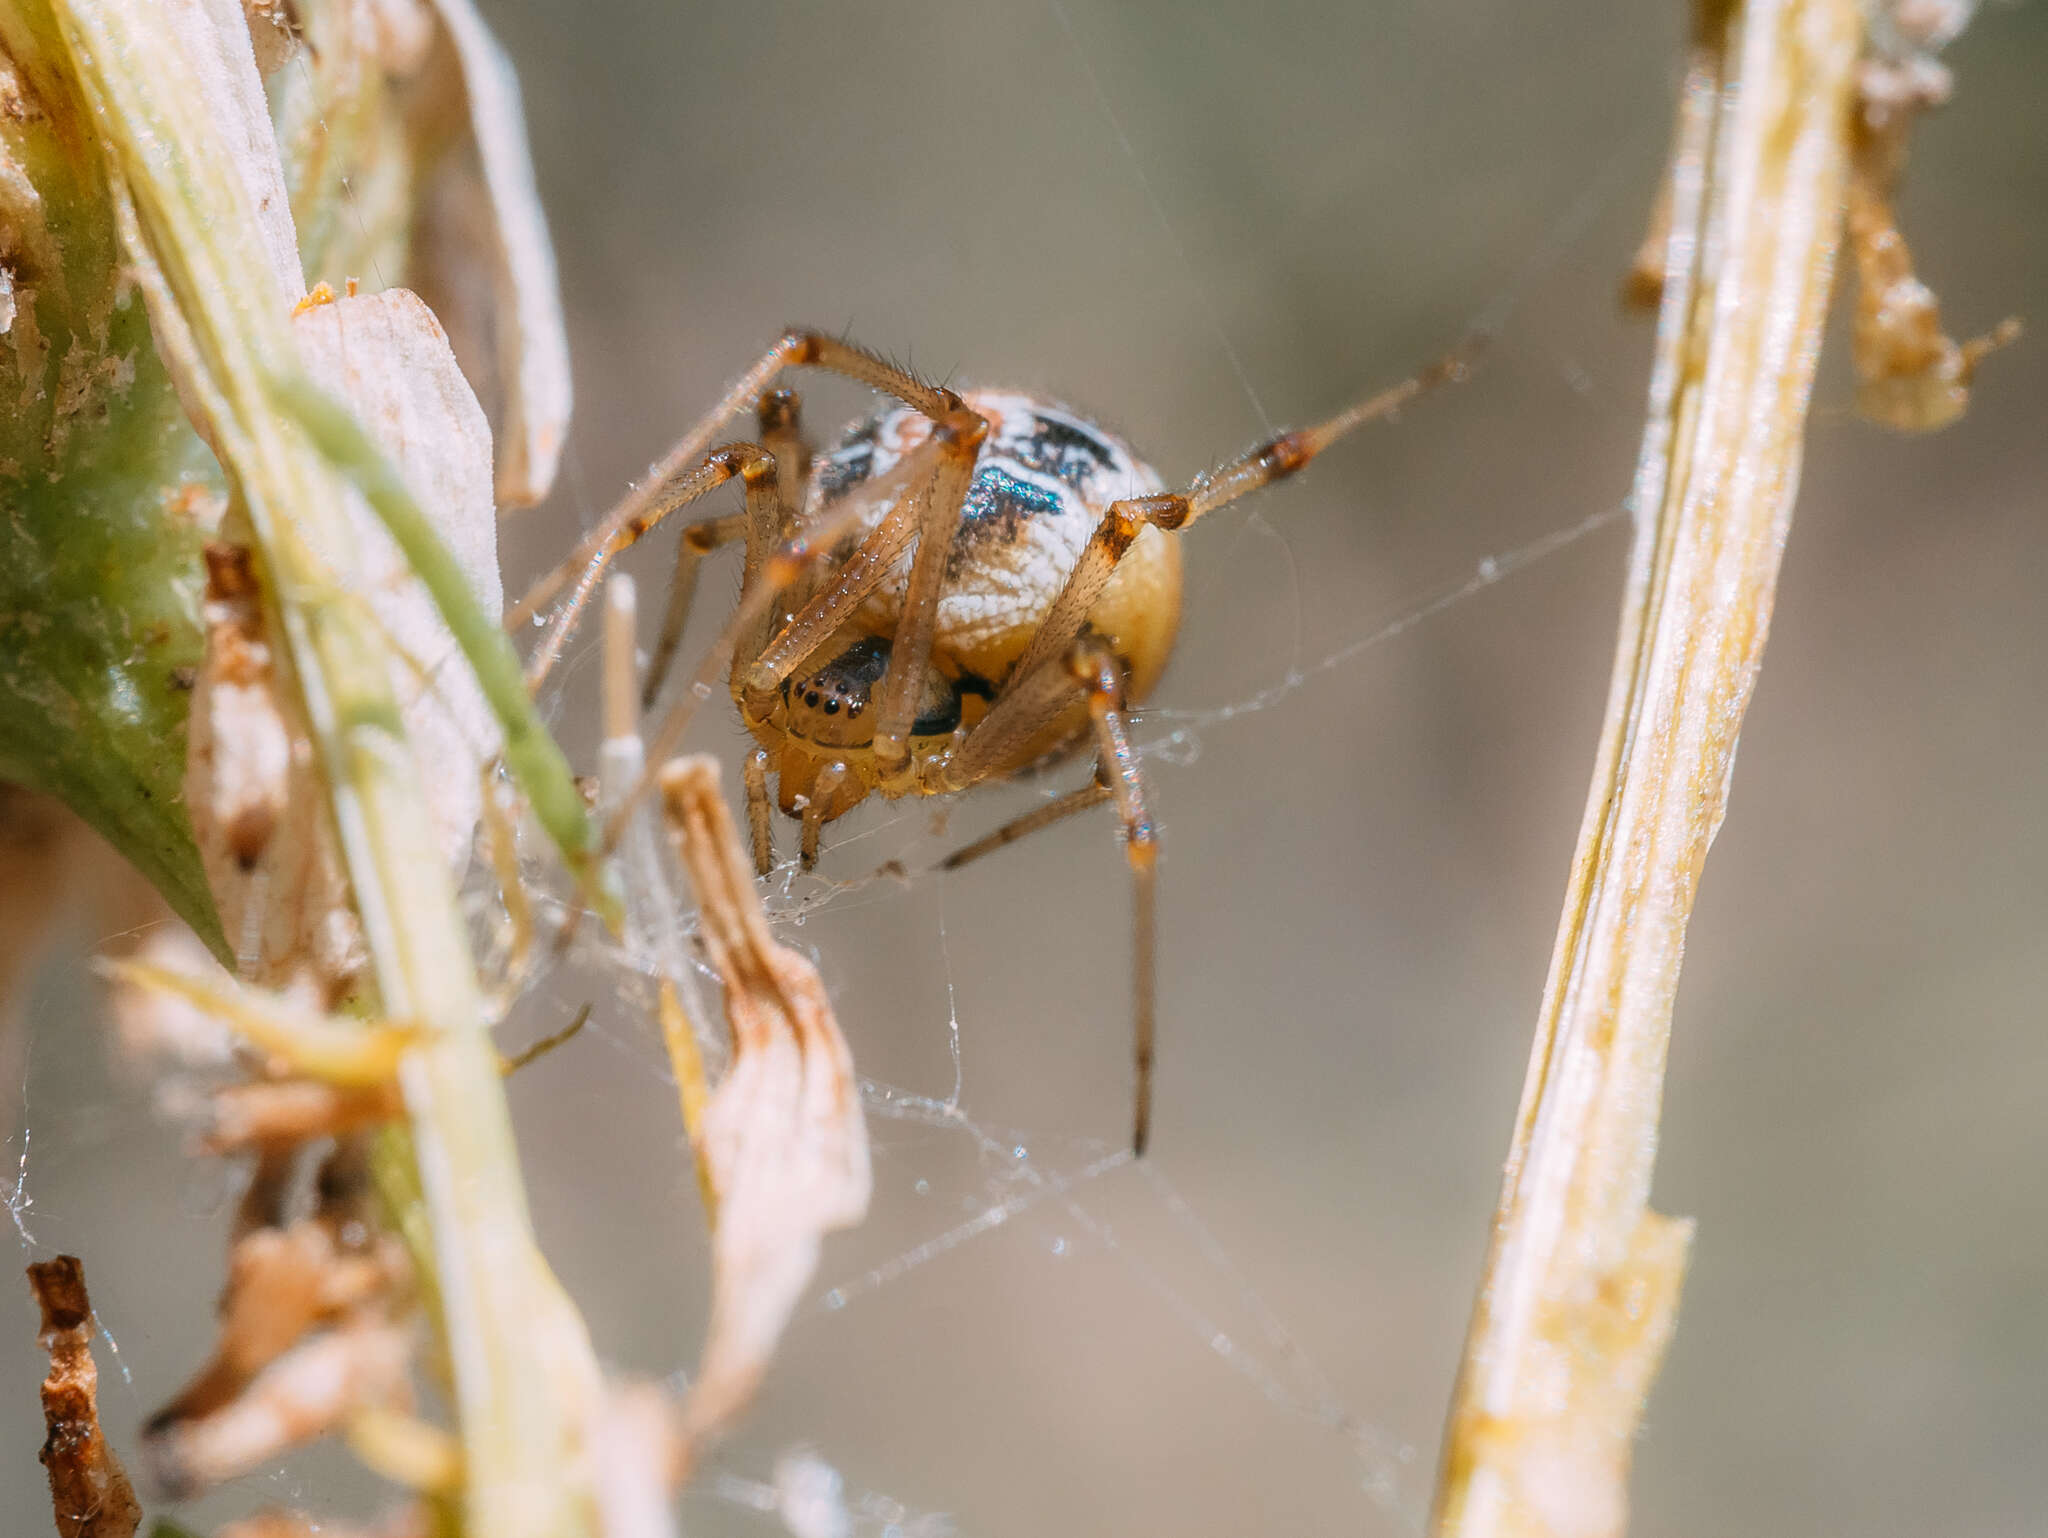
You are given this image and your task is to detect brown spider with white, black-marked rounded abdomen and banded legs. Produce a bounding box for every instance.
[508,330,1470,1155]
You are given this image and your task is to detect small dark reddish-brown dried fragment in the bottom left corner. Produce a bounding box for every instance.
[29,1255,141,1538]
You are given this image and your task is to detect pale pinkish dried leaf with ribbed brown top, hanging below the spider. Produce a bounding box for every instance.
[662,756,870,1468]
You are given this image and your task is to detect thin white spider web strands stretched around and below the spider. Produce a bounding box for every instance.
[552,15,1636,1536]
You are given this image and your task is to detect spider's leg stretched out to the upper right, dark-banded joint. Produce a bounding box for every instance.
[1006,340,1477,688]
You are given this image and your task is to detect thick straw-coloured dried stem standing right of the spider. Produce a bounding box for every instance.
[1434,0,1862,1538]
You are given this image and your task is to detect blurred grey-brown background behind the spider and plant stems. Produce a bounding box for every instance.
[0,0,2048,1538]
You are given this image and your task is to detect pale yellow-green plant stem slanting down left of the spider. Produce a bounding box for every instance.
[57,0,596,1538]
